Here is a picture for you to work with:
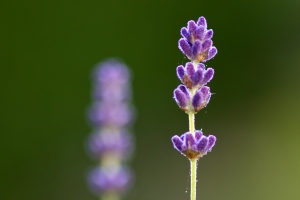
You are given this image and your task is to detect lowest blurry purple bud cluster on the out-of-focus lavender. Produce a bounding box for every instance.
[88,167,132,195]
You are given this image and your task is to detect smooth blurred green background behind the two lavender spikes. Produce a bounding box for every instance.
[0,0,300,200]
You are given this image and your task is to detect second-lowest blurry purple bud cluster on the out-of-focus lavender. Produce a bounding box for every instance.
[88,129,133,160]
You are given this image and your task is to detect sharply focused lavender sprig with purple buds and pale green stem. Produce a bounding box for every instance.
[172,17,217,200]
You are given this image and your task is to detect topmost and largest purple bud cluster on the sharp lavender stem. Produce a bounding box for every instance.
[178,17,217,62]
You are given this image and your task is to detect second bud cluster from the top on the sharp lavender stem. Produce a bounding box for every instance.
[176,62,214,89]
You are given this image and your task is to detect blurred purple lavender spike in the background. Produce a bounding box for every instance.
[87,59,133,199]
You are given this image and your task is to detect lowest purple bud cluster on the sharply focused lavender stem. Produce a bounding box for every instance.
[172,131,217,159]
